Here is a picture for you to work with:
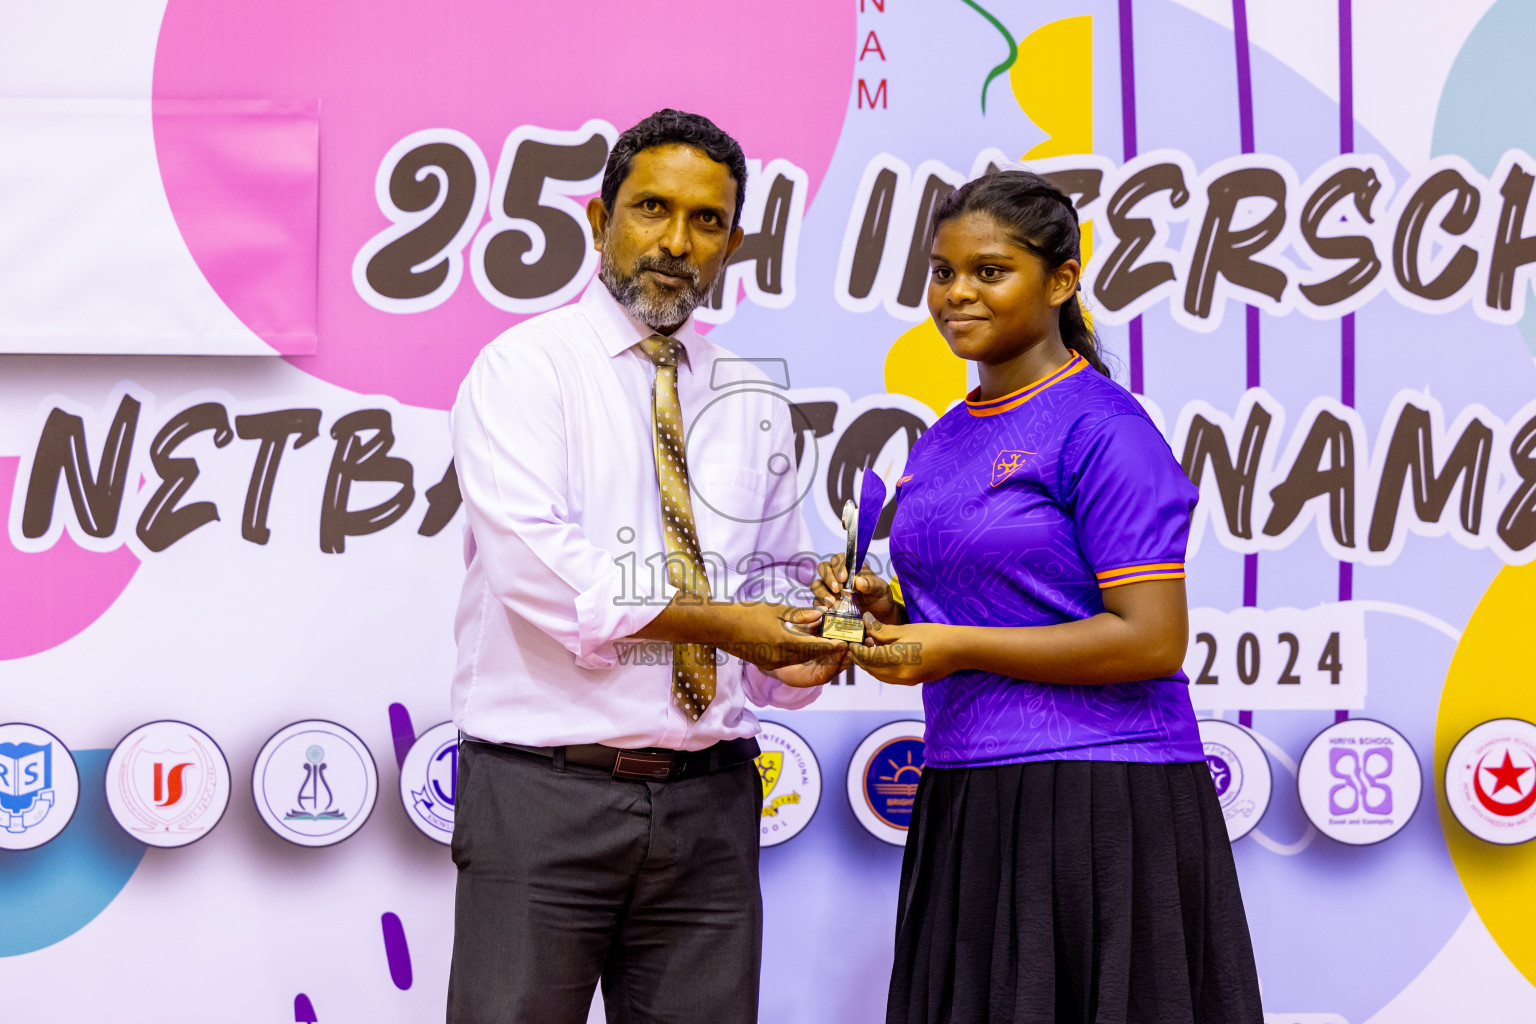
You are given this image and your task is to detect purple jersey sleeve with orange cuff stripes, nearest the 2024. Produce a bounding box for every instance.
[1063,413,1200,590]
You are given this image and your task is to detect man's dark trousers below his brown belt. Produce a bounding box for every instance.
[449,742,762,1024]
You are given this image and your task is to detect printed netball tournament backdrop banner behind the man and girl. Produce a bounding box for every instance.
[0,0,1536,1024]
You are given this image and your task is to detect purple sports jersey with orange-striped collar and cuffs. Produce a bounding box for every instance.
[891,353,1204,768]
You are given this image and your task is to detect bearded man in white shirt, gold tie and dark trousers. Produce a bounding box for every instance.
[449,111,846,1024]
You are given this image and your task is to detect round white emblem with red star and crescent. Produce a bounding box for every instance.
[1445,718,1536,846]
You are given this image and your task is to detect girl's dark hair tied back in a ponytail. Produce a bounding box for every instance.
[934,170,1114,376]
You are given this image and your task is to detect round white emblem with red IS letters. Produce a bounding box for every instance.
[106,722,230,847]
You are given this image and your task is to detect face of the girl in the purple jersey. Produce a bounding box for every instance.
[928,210,1080,364]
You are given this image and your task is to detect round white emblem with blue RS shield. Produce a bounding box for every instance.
[0,722,80,851]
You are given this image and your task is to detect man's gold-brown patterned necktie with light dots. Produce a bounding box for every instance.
[641,335,714,722]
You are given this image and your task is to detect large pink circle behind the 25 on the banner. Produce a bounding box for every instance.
[155,0,857,408]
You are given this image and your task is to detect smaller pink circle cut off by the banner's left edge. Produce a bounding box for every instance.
[0,456,138,660]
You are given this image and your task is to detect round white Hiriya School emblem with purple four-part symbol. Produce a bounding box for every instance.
[1296,718,1424,846]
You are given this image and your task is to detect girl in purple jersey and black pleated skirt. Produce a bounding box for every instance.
[814,170,1263,1024]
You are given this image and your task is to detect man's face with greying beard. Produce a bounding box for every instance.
[587,143,742,335]
